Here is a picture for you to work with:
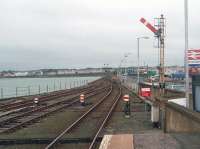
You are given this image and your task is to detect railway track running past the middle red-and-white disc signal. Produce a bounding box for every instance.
[0,82,111,133]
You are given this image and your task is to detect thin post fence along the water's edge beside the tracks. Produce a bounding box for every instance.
[0,80,88,99]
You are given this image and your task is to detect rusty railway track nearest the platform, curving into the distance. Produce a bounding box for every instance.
[45,83,122,149]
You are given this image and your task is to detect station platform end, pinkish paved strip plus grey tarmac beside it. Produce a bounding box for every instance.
[99,130,200,149]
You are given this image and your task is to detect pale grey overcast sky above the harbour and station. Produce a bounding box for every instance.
[0,0,200,70]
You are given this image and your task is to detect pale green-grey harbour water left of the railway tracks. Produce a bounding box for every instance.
[0,77,100,99]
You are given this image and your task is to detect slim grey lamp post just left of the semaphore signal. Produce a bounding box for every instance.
[137,36,149,93]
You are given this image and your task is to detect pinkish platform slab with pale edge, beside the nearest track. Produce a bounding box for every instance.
[99,134,134,149]
